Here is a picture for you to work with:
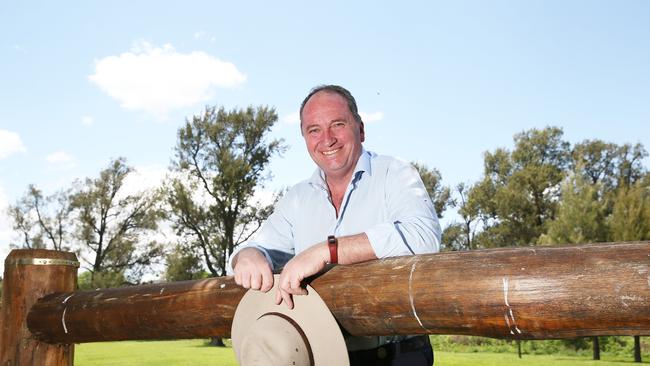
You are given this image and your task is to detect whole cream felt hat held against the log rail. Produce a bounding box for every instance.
[231,275,350,366]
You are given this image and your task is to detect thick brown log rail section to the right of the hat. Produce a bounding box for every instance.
[312,242,650,339]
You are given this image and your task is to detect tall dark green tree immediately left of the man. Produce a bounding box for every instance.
[166,106,285,276]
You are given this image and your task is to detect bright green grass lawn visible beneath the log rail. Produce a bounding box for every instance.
[75,339,635,366]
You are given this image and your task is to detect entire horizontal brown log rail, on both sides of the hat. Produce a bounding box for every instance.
[28,242,650,343]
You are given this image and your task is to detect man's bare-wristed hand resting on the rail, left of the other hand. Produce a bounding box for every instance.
[233,248,273,292]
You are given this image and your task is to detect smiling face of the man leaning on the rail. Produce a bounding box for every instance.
[301,91,364,179]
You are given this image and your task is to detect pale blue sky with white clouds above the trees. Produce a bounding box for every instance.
[0,0,650,272]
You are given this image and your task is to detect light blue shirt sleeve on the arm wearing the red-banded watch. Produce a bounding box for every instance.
[366,161,441,258]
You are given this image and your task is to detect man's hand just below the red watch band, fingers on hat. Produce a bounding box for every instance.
[274,243,330,309]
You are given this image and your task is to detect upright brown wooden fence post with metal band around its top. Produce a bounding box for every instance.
[0,249,79,366]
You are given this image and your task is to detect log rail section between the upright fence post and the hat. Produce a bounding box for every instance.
[27,277,246,343]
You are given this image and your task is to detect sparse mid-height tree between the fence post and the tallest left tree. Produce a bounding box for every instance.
[71,158,162,288]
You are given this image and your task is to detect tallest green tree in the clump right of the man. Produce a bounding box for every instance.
[468,127,570,247]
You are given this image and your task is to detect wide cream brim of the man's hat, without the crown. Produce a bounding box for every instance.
[231,275,350,366]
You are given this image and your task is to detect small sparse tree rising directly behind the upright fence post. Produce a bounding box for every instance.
[9,184,71,250]
